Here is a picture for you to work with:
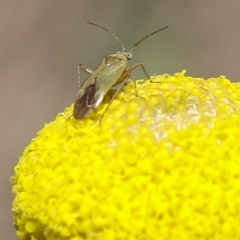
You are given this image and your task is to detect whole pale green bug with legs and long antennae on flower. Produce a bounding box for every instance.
[73,22,168,119]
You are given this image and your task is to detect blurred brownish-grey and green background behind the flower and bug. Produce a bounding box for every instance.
[0,0,240,240]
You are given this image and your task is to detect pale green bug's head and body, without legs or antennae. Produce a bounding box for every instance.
[73,52,132,119]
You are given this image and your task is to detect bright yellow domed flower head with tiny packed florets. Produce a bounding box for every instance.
[11,71,240,240]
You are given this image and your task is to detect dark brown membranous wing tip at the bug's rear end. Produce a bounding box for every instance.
[73,78,97,119]
